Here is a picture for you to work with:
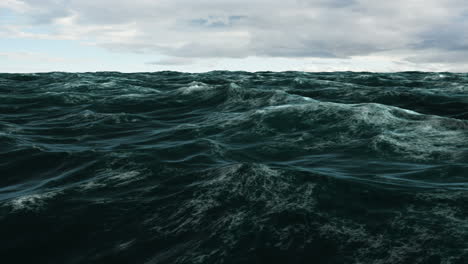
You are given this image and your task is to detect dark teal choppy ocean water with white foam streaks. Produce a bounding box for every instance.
[0,71,468,264]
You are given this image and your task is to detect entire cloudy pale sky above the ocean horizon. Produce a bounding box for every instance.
[0,0,468,72]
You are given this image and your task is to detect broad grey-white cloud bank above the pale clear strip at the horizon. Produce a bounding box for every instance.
[0,0,468,71]
